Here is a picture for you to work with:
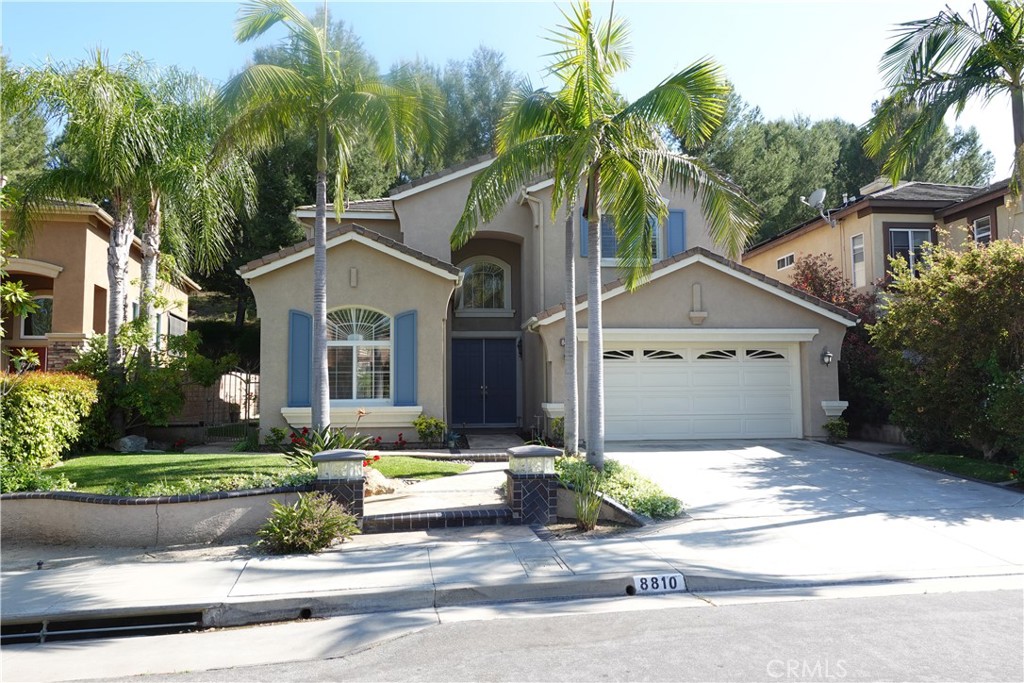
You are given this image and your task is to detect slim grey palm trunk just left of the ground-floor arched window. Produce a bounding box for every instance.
[311,117,331,429]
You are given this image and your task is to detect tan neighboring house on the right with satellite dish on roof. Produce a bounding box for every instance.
[742,180,1024,289]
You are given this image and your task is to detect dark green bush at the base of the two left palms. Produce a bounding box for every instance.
[68,319,236,450]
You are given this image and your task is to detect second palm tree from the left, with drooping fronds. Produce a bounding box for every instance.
[139,68,255,352]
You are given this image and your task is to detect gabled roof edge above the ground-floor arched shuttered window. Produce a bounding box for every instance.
[238,223,462,281]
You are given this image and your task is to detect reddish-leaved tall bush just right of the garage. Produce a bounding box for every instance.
[793,254,890,430]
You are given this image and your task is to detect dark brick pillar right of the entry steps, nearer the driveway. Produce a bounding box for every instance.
[506,445,562,524]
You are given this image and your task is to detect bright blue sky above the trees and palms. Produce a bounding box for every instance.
[0,0,1013,181]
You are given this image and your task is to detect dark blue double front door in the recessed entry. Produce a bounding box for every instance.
[452,339,517,427]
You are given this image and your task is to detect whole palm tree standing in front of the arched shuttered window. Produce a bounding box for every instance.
[221,0,441,429]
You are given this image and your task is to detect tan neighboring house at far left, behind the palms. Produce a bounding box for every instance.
[3,202,200,371]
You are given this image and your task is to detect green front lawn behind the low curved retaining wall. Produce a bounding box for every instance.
[52,453,469,494]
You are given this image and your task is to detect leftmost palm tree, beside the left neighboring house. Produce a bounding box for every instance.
[12,50,164,375]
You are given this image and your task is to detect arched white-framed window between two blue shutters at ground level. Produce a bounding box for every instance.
[327,307,391,404]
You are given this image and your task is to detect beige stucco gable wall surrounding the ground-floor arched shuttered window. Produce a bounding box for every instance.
[249,237,454,440]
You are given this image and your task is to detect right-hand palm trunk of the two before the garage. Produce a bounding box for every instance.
[587,174,604,470]
